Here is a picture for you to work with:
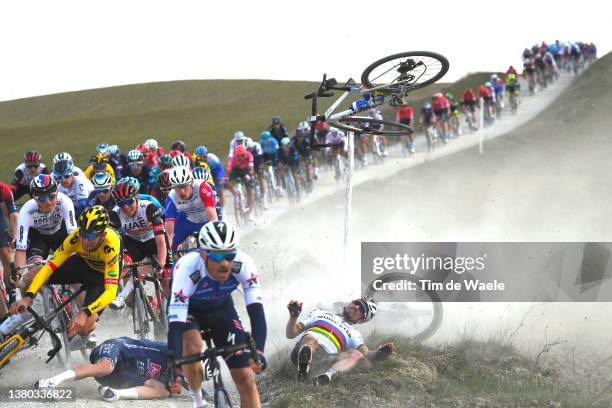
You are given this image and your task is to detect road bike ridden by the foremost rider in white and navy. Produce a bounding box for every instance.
[168,329,259,408]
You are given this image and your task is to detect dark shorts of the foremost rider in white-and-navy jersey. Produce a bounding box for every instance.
[185,296,250,368]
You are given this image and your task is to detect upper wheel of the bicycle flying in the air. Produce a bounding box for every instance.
[361,51,449,96]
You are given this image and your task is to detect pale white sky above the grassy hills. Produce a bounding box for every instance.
[0,0,612,100]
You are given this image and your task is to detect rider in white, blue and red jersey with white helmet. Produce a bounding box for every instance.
[165,167,217,251]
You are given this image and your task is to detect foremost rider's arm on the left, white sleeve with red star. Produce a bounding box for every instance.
[168,254,199,357]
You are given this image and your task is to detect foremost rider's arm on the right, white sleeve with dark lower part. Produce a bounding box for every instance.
[239,253,267,352]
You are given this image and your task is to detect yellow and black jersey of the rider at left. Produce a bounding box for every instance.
[27,227,123,315]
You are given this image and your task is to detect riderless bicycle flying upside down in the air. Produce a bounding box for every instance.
[304,51,449,141]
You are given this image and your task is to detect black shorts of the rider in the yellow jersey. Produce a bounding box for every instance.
[47,254,104,315]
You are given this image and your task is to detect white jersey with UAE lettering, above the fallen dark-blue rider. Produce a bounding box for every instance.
[111,200,164,242]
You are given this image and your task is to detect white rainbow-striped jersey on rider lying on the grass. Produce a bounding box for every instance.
[299,309,365,354]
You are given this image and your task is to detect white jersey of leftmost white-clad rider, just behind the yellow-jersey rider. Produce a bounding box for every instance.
[16,193,77,251]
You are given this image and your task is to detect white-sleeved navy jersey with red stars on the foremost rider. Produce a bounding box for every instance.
[168,250,263,322]
